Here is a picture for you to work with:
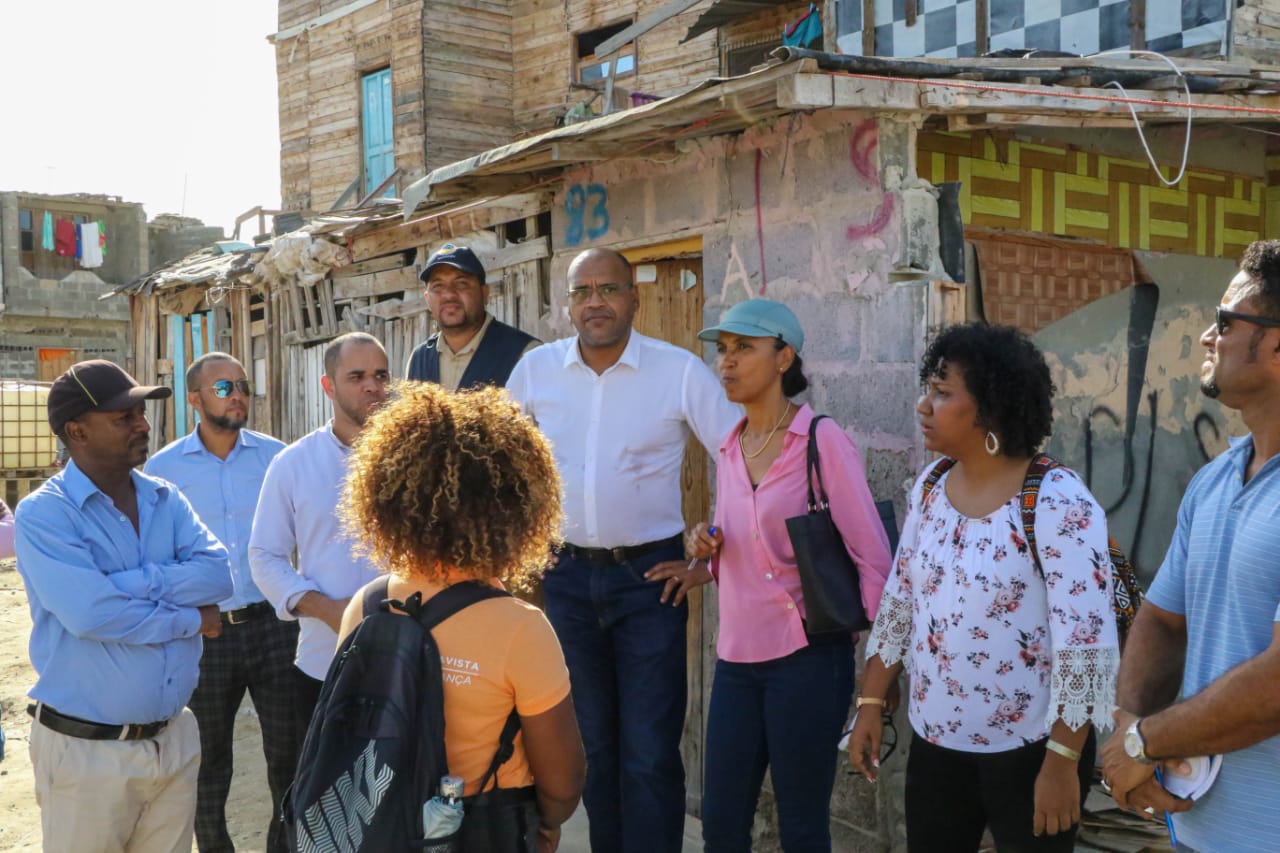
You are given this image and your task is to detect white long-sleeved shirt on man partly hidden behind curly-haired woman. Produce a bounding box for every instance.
[248,421,378,679]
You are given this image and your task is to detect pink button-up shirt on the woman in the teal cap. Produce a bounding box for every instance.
[712,406,892,663]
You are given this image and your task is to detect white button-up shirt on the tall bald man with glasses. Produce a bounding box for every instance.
[507,330,742,548]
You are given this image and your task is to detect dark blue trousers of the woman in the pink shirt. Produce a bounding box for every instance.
[703,637,854,853]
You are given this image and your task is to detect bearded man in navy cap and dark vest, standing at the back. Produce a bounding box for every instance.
[404,243,541,391]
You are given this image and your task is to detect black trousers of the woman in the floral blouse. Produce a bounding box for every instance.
[906,733,1097,853]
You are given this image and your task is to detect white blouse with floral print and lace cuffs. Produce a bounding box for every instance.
[867,467,1120,752]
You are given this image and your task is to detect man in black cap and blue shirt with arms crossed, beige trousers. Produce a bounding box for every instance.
[15,360,232,853]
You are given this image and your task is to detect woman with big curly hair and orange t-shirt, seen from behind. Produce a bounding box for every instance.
[340,383,586,853]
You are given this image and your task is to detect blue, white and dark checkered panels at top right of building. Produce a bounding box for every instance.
[837,0,1226,58]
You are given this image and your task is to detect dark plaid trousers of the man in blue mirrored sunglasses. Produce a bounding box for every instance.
[187,615,298,853]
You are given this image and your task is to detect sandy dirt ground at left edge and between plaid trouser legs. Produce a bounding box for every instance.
[0,560,271,853]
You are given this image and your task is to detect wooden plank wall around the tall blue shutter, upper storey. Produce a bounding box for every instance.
[275,0,425,211]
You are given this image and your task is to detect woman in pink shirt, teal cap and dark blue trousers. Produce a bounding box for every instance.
[650,300,891,853]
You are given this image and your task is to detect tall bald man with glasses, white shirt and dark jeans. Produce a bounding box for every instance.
[507,248,741,853]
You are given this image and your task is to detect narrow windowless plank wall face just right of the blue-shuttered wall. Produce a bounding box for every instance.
[422,0,516,169]
